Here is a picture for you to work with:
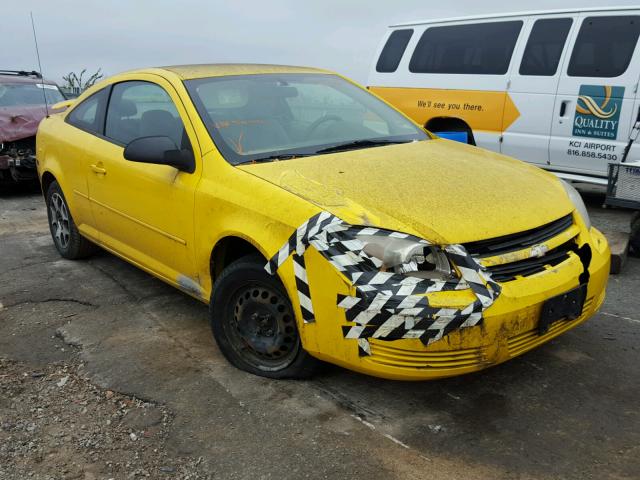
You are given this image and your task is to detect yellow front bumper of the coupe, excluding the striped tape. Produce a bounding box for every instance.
[283,228,610,380]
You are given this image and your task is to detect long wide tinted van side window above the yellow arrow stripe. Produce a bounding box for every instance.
[409,20,522,75]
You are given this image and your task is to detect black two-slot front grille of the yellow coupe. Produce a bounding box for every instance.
[465,214,576,282]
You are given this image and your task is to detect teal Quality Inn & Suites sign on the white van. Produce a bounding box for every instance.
[573,85,624,140]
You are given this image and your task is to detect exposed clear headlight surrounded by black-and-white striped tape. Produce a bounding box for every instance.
[356,234,454,280]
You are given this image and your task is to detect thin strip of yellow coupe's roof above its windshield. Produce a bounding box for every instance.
[153,63,332,80]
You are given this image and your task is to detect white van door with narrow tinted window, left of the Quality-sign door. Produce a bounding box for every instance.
[501,14,574,165]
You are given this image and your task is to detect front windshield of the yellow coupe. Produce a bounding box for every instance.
[185,74,429,165]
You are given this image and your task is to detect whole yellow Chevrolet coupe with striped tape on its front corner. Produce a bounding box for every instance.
[37,65,610,380]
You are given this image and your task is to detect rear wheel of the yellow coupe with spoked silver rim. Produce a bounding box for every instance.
[46,181,97,260]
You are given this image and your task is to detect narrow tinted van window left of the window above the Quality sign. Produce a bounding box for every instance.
[520,18,573,76]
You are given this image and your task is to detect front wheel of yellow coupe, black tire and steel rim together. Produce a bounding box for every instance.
[209,255,320,378]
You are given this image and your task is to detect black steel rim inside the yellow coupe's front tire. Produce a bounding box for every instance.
[224,284,300,371]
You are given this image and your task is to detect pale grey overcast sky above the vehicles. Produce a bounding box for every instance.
[5,0,637,84]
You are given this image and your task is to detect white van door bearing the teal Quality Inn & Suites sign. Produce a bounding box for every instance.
[549,11,640,182]
